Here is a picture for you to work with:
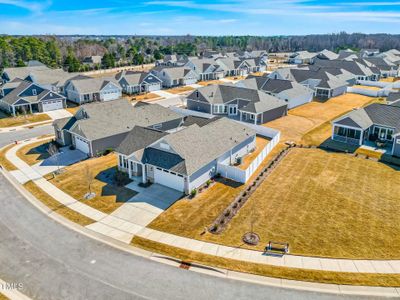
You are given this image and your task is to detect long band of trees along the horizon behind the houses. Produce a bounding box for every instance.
[0,32,400,72]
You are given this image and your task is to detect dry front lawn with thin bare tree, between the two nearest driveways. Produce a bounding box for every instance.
[46,154,136,214]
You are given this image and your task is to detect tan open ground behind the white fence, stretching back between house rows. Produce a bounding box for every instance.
[264,94,377,145]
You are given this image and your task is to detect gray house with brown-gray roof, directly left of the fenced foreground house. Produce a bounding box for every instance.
[53,99,183,156]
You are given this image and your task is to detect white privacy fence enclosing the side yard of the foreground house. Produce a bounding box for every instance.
[217,122,281,183]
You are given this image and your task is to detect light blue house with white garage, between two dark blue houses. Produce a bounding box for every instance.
[65,78,122,104]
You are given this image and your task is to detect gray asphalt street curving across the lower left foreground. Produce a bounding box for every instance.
[0,127,382,300]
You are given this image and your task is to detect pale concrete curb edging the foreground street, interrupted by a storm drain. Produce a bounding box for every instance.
[0,170,400,299]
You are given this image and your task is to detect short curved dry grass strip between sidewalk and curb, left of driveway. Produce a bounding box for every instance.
[24,181,95,226]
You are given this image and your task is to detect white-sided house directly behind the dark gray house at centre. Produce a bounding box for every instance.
[236,75,314,109]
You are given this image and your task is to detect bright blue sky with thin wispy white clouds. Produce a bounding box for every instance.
[0,0,400,35]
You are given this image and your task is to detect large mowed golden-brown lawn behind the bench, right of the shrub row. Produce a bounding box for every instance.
[203,149,400,259]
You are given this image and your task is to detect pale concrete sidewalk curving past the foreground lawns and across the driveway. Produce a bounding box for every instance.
[6,140,400,274]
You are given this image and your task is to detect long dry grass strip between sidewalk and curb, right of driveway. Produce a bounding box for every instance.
[131,236,400,287]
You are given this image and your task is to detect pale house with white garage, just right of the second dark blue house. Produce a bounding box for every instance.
[151,66,198,88]
